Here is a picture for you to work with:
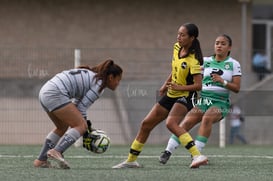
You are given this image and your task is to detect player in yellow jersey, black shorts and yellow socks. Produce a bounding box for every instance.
[112,23,207,169]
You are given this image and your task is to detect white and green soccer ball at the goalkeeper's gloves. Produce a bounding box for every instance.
[91,130,110,153]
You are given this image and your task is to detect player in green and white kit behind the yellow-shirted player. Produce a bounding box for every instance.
[159,34,242,164]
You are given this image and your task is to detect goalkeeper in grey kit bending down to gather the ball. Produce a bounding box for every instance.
[33,59,122,169]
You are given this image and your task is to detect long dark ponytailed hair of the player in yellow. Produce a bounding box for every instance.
[182,23,204,65]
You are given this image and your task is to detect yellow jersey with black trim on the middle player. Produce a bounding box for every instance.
[167,43,201,98]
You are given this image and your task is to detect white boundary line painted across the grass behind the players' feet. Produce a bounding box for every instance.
[0,155,273,159]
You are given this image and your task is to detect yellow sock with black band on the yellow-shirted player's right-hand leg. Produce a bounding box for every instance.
[179,133,201,156]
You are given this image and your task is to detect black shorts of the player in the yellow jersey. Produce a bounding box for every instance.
[158,92,197,111]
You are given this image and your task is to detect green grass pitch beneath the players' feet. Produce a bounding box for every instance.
[0,145,273,181]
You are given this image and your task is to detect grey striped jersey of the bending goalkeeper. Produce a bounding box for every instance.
[48,69,103,117]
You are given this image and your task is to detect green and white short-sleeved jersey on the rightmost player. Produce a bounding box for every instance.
[201,56,242,99]
